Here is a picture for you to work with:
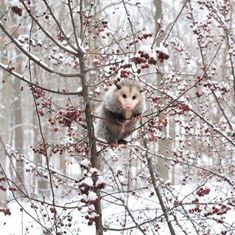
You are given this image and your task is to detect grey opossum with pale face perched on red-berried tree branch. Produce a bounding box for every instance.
[95,79,145,144]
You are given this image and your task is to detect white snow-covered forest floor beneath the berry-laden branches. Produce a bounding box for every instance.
[0,183,235,235]
